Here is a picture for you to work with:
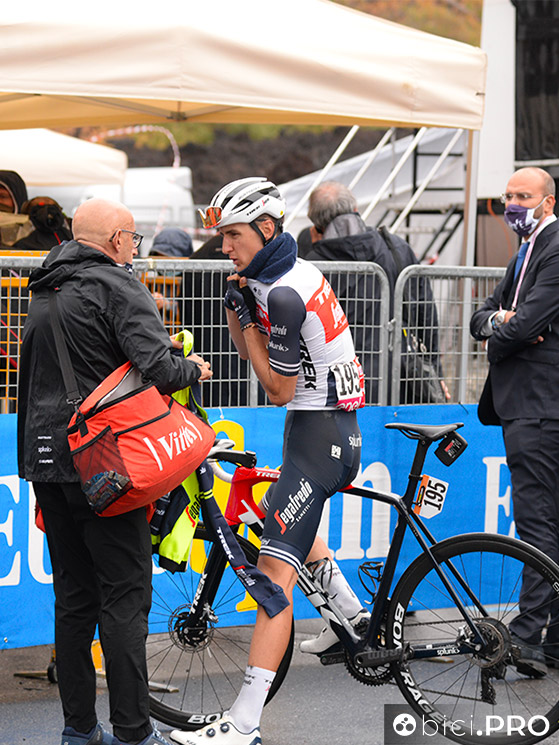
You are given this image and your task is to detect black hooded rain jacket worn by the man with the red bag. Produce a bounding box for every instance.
[18,241,200,482]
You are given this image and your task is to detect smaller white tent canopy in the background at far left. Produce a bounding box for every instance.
[0,129,128,186]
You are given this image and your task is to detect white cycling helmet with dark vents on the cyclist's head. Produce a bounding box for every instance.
[198,176,285,228]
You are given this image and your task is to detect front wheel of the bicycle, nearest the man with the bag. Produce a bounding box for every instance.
[147,526,294,730]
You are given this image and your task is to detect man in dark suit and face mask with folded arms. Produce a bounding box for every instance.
[470,168,559,677]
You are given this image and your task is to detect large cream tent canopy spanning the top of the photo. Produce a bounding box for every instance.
[0,0,486,129]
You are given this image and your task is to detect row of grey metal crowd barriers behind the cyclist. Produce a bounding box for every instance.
[0,255,504,413]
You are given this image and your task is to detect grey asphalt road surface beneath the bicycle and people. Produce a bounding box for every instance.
[0,619,398,745]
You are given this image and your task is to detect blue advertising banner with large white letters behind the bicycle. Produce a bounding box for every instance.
[0,405,514,649]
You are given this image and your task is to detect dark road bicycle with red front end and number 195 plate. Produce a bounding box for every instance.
[148,422,559,745]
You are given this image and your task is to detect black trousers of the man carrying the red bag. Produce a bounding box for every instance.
[33,482,152,742]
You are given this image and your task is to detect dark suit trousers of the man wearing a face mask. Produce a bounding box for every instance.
[502,419,559,644]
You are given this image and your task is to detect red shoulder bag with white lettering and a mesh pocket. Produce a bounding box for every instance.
[68,362,215,516]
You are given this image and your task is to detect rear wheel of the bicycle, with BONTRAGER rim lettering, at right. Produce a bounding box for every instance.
[387,533,559,745]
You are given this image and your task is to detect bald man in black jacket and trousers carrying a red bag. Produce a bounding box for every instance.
[18,199,212,745]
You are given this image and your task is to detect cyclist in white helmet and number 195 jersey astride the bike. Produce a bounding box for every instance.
[170,178,364,745]
